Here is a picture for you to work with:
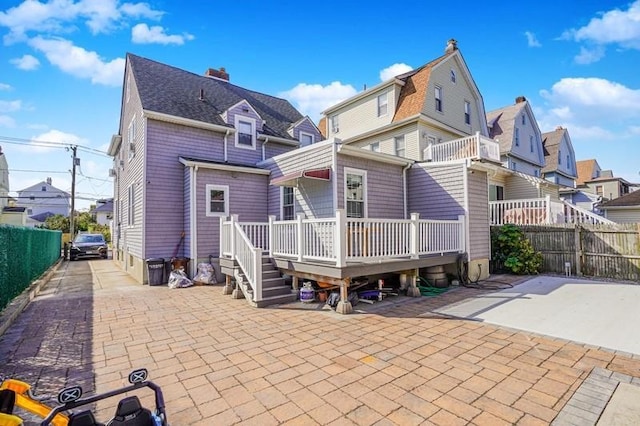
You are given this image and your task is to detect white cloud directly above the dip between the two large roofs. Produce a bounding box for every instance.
[278,81,357,120]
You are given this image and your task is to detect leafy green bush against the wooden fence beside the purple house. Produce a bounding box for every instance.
[491,225,542,275]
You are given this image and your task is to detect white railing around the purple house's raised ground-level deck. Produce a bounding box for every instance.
[225,210,466,273]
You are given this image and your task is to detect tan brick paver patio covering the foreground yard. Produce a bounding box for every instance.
[0,261,640,425]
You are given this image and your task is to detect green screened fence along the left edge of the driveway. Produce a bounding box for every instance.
[0,225,62,310]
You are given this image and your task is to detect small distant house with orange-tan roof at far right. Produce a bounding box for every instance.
[576,159,635,200]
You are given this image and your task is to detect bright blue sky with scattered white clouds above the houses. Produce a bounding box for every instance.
[0,0,640,209]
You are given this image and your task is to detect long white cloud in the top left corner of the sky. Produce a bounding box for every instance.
[0,0,164,44]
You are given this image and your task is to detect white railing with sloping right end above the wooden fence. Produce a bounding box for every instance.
[489,195,612,225]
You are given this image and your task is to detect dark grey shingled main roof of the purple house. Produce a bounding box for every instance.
[127,53,303,141]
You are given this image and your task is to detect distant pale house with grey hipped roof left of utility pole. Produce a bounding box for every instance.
[17,178,71,216]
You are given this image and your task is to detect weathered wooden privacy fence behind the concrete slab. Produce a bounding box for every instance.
[492,224,640,281]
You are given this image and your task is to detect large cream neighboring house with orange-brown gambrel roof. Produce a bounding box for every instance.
[319,40,488,161]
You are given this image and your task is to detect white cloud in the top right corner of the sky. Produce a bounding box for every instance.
[561,0,640,64]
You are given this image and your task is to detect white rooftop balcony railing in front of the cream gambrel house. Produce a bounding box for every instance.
[423,133,500,163]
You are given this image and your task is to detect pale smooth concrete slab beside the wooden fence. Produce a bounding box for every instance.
[438,276,640,354]
